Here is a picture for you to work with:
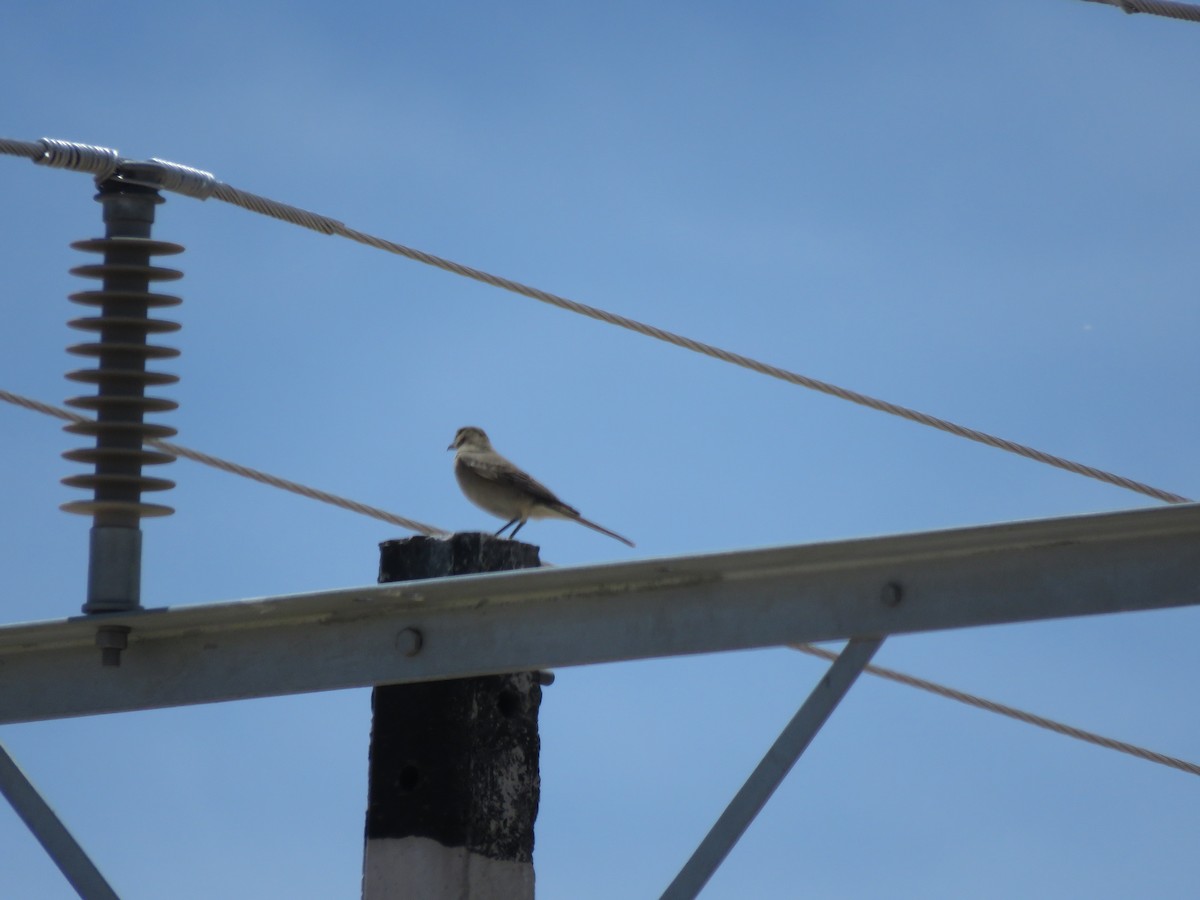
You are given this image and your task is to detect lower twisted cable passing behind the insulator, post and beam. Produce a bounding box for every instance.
[0,390,1200,775]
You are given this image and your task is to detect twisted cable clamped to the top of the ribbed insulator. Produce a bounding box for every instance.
[0,138,1200,511]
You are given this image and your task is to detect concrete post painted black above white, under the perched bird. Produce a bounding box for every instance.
[362,533,541,900]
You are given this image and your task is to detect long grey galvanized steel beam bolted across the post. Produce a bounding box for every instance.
[0,504,1200,722]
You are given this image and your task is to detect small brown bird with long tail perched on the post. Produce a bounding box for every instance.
[446,425,634,547]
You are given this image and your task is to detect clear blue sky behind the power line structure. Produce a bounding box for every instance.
[0,0,1200,900]
